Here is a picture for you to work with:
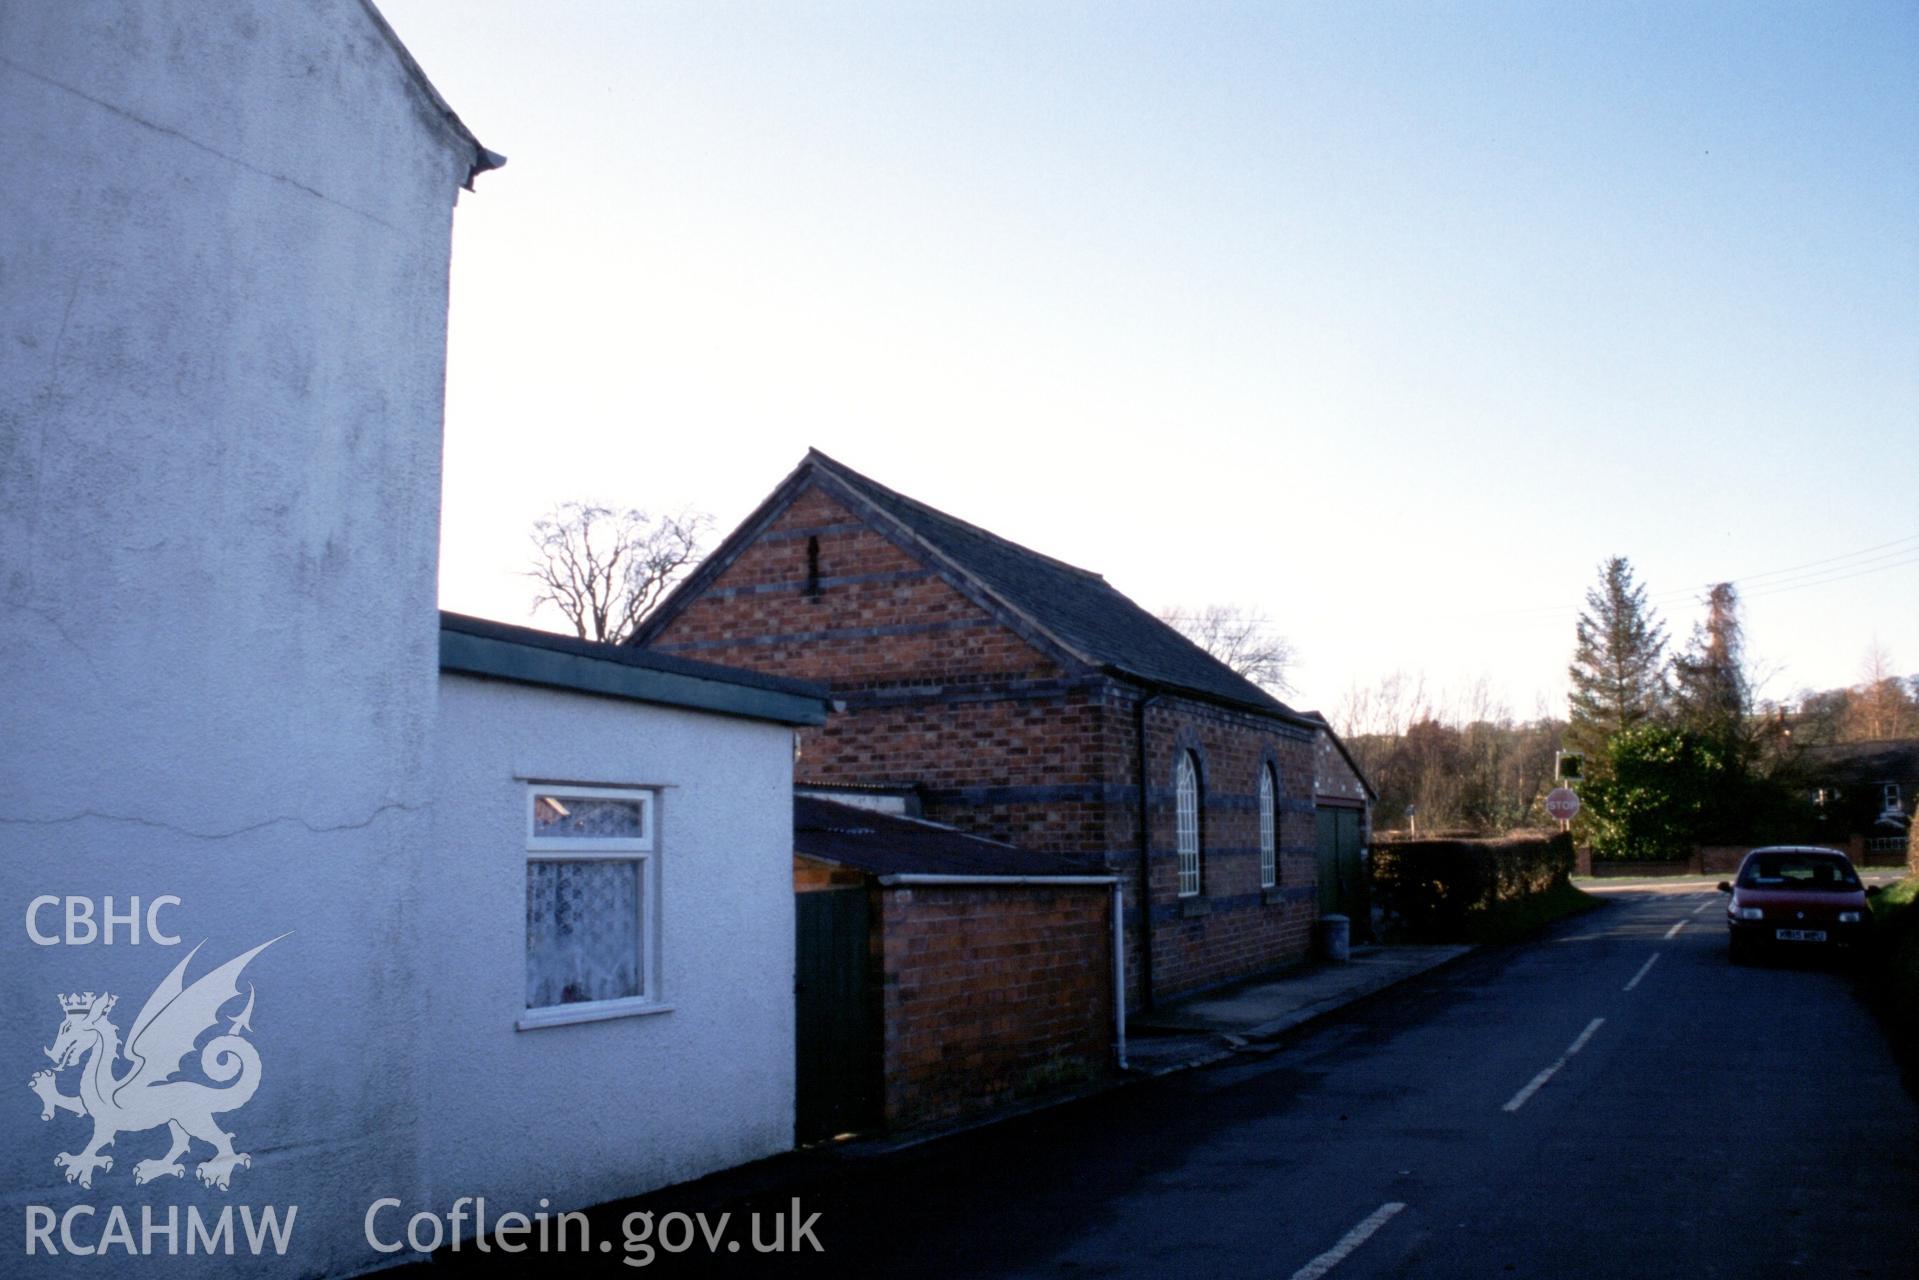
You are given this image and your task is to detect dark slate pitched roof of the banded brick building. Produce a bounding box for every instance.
[633,449,1316,727]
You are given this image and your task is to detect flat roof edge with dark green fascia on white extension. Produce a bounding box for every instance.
[439,610,829,725]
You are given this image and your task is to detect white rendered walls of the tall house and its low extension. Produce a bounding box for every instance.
[0,0,793,1276]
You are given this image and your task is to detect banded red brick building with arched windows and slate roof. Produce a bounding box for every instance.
[633,451,1366,1006]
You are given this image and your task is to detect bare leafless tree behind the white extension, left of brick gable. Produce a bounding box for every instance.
[526,503,712,643]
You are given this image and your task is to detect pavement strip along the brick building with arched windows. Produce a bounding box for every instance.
[1126,946,1474,1077]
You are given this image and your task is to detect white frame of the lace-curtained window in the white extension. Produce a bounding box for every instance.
[516,781,672,1031]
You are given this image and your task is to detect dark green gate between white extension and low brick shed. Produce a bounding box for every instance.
[793,889,879,1142]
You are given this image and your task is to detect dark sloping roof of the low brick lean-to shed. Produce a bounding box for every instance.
[793,796,1098,879]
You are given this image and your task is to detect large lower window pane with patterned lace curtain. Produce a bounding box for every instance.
[526,860,641,1009]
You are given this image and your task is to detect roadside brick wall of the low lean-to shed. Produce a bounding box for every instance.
[881,885,1113,1128]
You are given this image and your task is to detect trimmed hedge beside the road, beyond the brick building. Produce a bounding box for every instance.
[1372,831,1574,938]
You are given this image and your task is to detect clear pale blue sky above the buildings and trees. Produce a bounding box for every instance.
[382,0,1919,716]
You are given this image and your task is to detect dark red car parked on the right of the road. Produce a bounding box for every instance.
[1719,844,1877,963]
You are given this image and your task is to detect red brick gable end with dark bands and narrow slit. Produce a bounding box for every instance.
[652,489,1105,855]
